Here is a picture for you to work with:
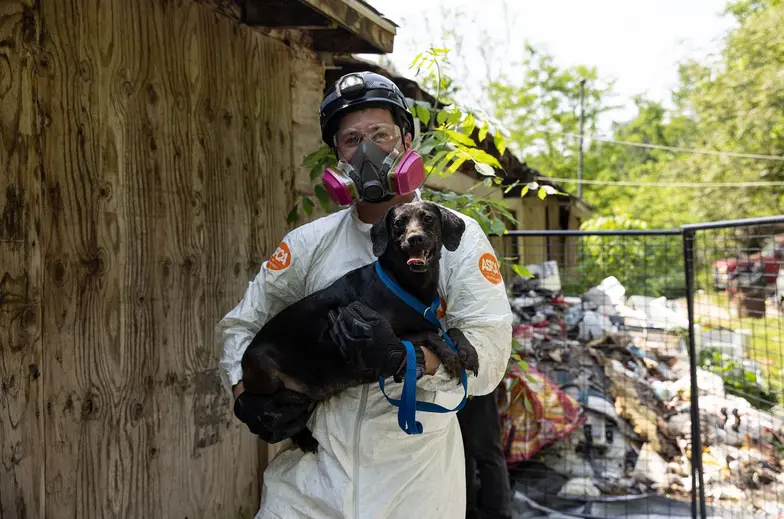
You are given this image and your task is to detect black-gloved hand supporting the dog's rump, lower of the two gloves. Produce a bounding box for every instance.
[234,389,313,443]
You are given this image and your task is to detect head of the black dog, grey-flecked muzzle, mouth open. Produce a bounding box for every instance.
[370,202,465,273]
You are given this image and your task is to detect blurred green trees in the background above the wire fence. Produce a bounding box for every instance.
[489,0,784,228]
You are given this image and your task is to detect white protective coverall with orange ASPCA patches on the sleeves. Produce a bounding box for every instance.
[216,201,512,519]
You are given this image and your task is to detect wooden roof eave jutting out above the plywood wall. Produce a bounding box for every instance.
[243,0,395,54]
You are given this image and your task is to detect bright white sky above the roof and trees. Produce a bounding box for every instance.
[358,0,733,127]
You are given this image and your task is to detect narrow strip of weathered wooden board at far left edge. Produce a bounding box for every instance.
[0,0,44,518]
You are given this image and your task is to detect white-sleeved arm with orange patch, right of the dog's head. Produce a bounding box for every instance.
[417,215,512,395]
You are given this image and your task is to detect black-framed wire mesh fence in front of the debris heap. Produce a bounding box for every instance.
[499,217,784,518]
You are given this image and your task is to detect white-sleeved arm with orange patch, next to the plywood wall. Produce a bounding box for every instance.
[215,236,308,399]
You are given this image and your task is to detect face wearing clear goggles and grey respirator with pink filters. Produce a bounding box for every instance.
[322,124,425,206]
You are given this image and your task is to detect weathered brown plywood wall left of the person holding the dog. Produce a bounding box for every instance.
[0,0,304,519]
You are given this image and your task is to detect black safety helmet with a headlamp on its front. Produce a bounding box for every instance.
[319,72,414,149]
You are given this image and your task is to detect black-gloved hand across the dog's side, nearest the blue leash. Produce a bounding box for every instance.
[329,301,425,382]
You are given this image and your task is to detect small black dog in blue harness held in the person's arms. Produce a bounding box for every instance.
[242,202,479,451]
